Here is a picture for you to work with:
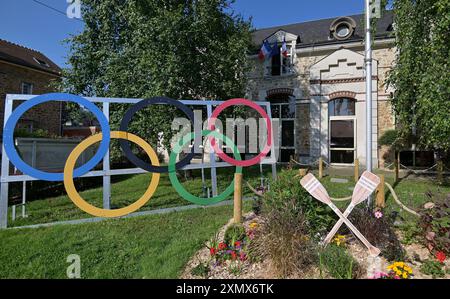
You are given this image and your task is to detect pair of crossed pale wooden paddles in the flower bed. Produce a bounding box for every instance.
[300,171,380,256]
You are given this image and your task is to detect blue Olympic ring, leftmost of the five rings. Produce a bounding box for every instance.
[3,93,111,182]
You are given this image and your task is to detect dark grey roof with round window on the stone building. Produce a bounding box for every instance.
[253,11,394,48]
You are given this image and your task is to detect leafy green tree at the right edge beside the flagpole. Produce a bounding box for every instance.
[388,0,450,152]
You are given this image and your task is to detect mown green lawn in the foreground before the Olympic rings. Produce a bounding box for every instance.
[0,204,249,278]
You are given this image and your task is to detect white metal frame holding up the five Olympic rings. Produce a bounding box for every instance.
[0,94,277,229]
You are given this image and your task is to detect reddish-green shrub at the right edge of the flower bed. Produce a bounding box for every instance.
[420,192,450,255]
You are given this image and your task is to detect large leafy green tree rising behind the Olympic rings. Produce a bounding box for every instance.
[62,0,251,163]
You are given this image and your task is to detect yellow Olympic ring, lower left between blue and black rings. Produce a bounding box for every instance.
[64,131,160,218]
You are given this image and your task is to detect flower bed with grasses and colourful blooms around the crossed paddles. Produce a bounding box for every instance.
[182,171,450,279]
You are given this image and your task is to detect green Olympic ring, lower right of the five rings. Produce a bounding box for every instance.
[169,130,242,205]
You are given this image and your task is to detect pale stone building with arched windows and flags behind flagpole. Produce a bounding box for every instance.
[247,12,395,167]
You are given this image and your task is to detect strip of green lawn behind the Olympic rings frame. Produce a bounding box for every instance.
[8,167,270,227]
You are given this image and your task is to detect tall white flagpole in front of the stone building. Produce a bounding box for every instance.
[365,0,372,207]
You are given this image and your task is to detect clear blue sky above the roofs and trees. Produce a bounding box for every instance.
[0,0,364,67]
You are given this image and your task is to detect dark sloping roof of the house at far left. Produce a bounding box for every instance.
[0,39,61,75]
